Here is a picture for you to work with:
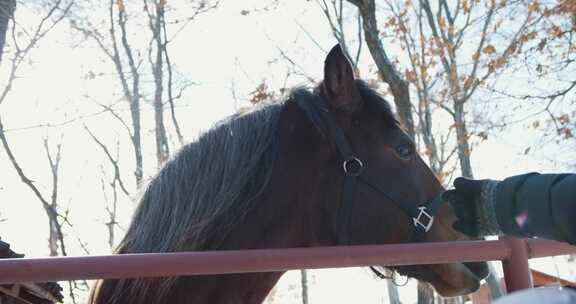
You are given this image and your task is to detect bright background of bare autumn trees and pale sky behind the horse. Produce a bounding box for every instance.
[0,0,576,303]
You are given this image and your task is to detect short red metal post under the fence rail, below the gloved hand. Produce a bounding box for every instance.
[501,237,533,293]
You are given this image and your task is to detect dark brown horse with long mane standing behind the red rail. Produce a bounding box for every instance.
[90,45,488,304]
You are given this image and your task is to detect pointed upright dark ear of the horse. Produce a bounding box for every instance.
[324,44,362,112]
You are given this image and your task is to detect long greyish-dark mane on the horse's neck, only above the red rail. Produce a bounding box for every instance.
[119,103,283,253]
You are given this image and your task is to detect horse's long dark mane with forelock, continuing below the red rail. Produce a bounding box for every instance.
[90,81,397,304]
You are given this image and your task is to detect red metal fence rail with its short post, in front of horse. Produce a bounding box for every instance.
[0,238,576,291]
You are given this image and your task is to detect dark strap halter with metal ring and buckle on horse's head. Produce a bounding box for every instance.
[294,91,443,245]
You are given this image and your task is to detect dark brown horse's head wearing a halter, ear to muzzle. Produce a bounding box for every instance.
[280,46,488,296]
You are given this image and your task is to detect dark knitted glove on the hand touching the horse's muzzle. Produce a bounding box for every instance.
[443,177,500,237]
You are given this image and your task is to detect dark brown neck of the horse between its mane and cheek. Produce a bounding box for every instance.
[173,104,339,304]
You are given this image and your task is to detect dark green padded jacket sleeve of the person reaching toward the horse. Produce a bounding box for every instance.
[494,173,576,244]
